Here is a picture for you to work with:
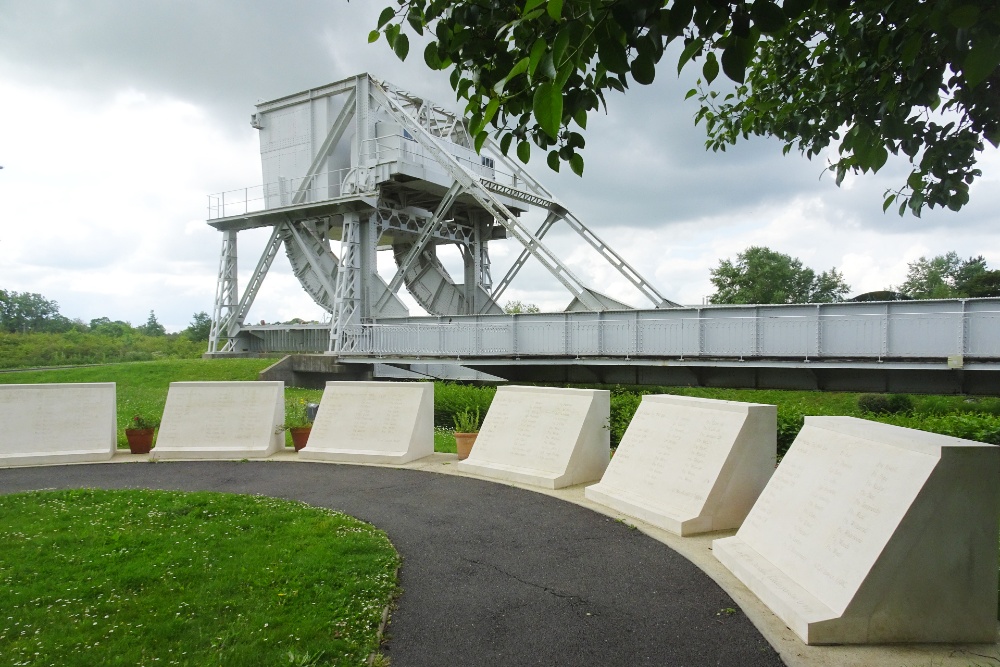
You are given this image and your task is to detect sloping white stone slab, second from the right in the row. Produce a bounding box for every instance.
[584,395,777,536]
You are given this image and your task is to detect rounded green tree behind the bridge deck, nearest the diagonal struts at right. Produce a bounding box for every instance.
[709,246,851,303]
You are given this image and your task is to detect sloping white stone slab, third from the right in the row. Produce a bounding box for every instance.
[457,386,611,489]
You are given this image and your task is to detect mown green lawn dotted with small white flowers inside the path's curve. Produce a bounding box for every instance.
[0,489,400,666]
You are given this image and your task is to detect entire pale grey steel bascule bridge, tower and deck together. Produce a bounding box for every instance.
[207,74,1000,394]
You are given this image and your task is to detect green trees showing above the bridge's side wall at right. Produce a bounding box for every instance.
[709,246,1000,304]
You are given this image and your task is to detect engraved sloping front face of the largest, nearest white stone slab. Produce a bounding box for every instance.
[738,429,936,613]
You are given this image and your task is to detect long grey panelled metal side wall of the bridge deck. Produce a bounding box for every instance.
[330,299,1000,361]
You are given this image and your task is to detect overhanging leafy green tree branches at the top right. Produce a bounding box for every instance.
[369,0,1000,215]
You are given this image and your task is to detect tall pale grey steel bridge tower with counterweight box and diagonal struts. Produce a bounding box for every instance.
[208,74,677,354]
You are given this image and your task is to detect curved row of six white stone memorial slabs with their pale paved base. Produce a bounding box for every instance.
[0,382,1000,665]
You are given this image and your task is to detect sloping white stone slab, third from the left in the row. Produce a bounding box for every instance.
[298,382,434,464]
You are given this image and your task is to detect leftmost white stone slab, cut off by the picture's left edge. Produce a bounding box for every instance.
[0,382,117,466]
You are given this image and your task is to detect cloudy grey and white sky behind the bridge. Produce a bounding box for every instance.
[0,0,1000,331]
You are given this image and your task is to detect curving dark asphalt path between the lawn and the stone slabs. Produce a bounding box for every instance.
[0,461,783,667]
